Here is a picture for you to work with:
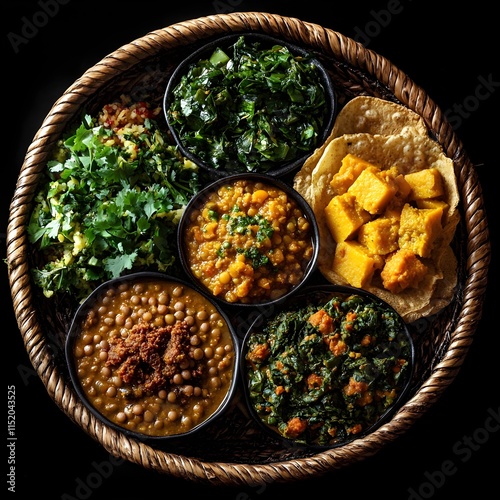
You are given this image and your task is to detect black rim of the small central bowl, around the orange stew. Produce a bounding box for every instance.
[177,173,319,308]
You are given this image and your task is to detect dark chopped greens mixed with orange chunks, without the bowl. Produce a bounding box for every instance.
[245,294,412,446]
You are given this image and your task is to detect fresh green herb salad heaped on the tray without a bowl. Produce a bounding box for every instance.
[28,97,199,300]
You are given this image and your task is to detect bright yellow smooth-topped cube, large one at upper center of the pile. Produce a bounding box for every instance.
[347,169,396,215]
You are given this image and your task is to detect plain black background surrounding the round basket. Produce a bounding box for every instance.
[0,0,500,500]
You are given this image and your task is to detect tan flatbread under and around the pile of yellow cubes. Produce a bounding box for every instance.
[294,97,460,322]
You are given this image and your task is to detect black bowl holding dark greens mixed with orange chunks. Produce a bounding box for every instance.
[240,284,415,449]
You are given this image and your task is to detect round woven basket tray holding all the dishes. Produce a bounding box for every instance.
[7,12,490,485]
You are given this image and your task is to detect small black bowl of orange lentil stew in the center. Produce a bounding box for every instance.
[177,173,319,307]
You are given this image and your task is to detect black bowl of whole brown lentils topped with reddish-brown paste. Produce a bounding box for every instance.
[65,272,239,442]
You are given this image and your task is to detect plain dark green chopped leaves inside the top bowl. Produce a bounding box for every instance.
[167,36,327,172]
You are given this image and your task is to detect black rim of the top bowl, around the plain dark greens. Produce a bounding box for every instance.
[163,32,337,178]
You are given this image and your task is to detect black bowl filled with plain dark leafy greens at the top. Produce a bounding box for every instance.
[163,32,336,178]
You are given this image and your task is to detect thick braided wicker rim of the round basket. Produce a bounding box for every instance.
[7,12,490,485]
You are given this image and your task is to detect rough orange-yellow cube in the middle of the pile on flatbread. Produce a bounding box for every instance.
[358,217,399,255]
